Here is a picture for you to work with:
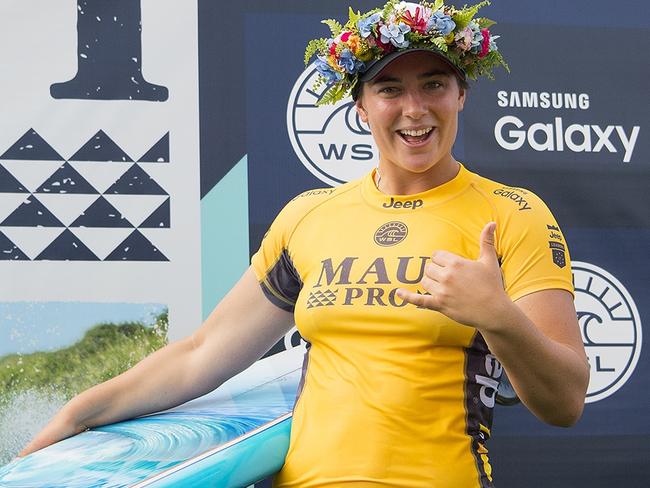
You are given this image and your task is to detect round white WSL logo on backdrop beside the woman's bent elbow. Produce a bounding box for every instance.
[572,262,641,403]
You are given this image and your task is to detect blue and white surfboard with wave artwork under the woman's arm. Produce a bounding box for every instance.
[0,347,304,488]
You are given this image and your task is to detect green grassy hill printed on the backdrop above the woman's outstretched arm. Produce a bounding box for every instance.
[0,311,168,408]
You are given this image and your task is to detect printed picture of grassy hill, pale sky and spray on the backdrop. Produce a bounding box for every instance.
[0,302,168,469]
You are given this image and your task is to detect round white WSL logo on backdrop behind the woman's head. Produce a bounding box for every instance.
[287,63,379,186]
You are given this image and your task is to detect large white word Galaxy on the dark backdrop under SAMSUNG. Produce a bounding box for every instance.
[494,115,641,163]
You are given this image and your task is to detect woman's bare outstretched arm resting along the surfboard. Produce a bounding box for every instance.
[19,268,293,456]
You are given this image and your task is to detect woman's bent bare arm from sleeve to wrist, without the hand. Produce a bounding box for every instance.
[481,290,589,427]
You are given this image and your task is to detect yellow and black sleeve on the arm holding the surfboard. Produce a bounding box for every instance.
[251,202,302,312]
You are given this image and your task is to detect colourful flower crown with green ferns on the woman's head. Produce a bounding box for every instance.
[305,0,509,105]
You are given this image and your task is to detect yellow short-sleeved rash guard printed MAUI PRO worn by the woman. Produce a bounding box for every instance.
[252,166,573,488]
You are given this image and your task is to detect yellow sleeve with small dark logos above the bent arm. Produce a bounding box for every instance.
[497,188,574,301]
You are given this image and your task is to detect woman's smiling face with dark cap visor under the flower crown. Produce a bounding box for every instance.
[356,52,465,179]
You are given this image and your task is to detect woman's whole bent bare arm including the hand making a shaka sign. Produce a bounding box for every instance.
[398,222,589,426]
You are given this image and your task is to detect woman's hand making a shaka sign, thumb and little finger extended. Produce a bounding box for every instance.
[397,222,512,330]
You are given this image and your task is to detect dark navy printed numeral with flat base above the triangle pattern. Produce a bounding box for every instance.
[50,0,169,102]
